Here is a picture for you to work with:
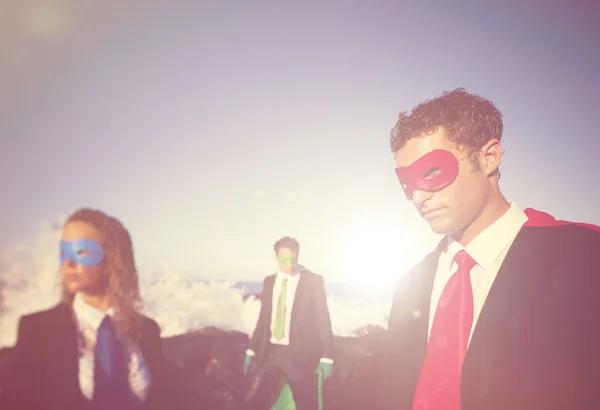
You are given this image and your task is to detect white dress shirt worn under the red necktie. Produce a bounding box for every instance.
[428,202,528,343]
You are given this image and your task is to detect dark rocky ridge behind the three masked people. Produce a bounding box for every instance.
[0,326,385,410]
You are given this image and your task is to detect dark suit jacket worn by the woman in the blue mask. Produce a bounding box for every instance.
[3,303,163,410]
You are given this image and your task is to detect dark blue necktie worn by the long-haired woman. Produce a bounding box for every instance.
[90,316,130,410]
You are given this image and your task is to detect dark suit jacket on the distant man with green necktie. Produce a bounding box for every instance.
[250,270,334,380]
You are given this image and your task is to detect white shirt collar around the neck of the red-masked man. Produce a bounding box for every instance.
[446,202,527,271]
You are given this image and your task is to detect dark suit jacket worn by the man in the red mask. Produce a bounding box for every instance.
[383,225,600,410]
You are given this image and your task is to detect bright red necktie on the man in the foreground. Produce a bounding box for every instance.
[412,250,475,410]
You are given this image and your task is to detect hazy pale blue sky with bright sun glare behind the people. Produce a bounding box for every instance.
[0,1,600,283]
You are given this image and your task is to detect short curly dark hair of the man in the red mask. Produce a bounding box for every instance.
[390,88,503,168]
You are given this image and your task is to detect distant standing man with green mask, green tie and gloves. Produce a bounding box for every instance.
[244,237,333,410]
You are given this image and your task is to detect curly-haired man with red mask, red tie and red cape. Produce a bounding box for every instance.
[384,89,600,410]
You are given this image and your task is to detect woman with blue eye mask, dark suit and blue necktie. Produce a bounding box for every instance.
[6,209,163,410]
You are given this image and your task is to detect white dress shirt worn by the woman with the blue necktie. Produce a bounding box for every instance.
[73,294,150,401]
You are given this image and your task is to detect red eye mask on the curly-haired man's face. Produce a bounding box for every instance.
[396,149,459,200]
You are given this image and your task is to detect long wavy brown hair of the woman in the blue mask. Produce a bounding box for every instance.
[62,208,142,345]
